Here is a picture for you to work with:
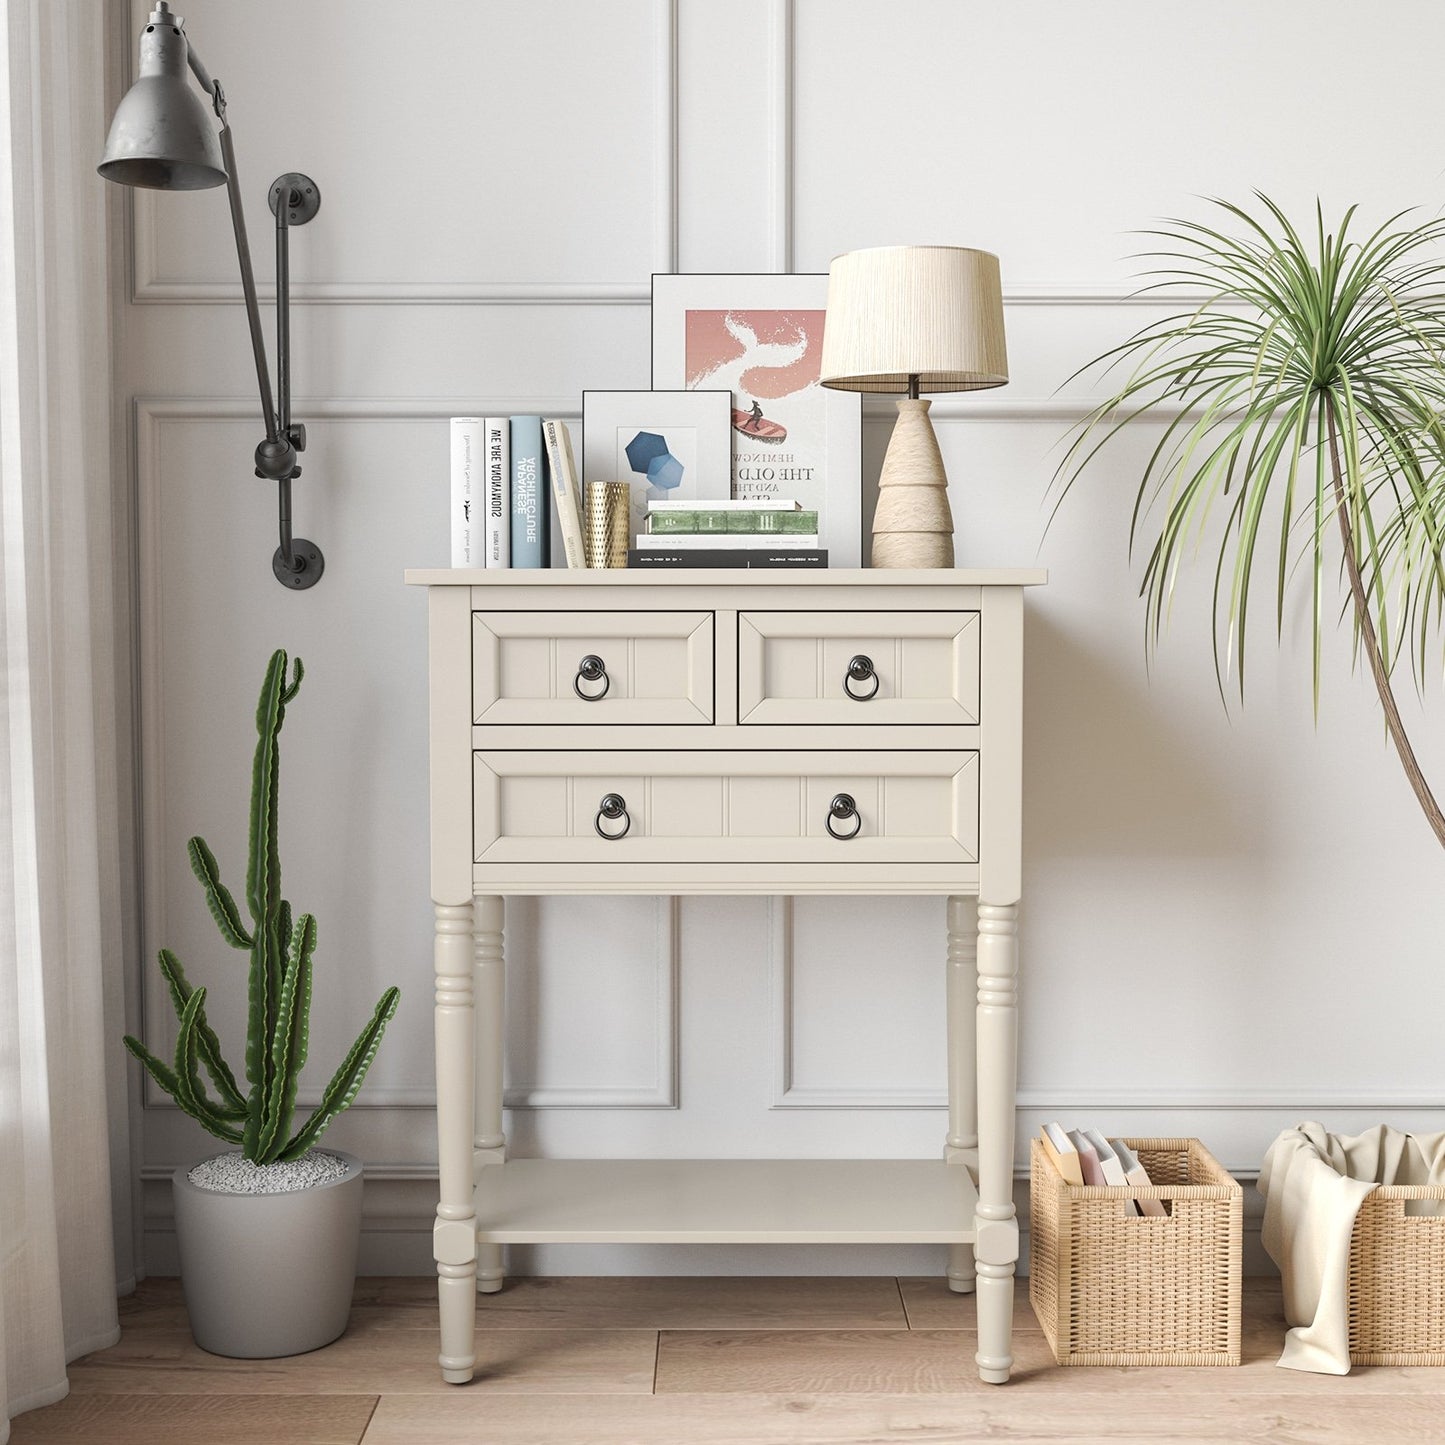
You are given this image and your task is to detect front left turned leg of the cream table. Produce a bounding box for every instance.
[432,900,477,1384]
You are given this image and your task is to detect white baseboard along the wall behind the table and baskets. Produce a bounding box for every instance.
[142,1165,1277,1277]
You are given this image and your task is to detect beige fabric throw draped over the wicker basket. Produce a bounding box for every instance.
[1260,1123,1445,1374]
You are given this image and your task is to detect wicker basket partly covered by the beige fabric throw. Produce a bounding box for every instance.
[1350,1185,1445,1364]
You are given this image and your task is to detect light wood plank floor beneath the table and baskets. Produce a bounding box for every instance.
[12,1279,1445,1445]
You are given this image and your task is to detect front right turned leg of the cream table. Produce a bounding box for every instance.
[974,900,1019,1384]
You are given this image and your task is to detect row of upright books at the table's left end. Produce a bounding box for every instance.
[451,416,585,568]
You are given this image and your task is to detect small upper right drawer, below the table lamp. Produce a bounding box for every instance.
[737,611,980,724]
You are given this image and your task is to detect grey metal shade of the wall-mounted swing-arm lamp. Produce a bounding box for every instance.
[97,12,225,191]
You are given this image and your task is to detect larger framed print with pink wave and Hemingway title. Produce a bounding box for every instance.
[652,275,863,566]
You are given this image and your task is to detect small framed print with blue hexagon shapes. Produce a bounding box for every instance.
[582,389,731,538]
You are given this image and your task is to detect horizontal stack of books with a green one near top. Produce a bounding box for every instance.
[627,497,828,568]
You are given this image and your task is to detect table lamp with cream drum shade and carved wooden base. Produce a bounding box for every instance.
[821,246,1009,566]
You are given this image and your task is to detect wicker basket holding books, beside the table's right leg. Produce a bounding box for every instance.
[1029,1139,1242,1364]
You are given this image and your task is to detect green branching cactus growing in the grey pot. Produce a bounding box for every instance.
[126,649,400,1165]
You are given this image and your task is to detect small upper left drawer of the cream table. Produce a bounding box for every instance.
[471,611,714,725]
